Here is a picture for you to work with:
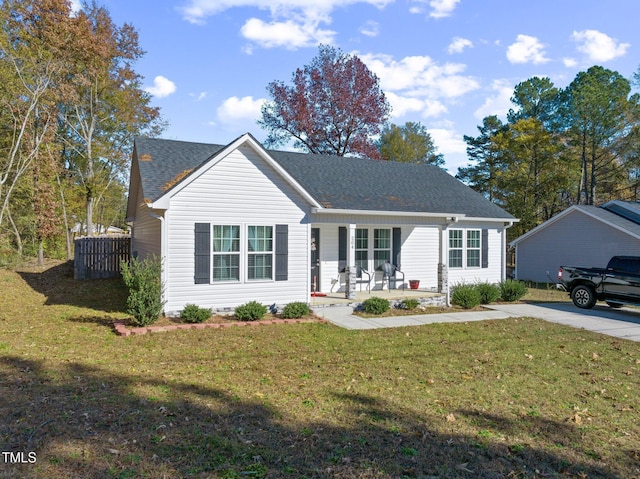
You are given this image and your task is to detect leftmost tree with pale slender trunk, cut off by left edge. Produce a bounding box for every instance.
[0,0,71,234]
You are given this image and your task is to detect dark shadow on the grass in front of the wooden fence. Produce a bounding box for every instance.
[18,261,127,313]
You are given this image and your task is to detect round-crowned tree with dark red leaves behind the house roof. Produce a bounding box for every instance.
[258,45,390,158]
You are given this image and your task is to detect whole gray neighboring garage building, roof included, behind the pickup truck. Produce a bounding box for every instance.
[510,201,640,283]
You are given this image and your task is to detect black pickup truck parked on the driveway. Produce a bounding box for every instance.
[558,256,640,308]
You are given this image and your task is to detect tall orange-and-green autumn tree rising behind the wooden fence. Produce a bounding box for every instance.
[59,3,164,235]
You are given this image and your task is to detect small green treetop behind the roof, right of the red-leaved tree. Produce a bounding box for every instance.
[378,121,444,166]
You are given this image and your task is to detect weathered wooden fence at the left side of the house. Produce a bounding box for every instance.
[73,235,131,279]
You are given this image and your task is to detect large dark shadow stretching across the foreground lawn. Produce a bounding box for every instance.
[0,357,635,478]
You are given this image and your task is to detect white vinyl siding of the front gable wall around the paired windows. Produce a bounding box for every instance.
[158,146,310,314]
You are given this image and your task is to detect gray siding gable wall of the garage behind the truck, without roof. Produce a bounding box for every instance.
[515,209,640,282]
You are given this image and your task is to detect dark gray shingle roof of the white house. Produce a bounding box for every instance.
[134,138,515,220]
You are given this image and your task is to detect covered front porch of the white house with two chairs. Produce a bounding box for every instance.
[309,217,446,304]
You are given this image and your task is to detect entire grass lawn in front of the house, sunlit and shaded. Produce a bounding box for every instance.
[0,265,640,478]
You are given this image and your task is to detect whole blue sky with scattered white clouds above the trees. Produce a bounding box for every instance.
[92,0,640,174]
